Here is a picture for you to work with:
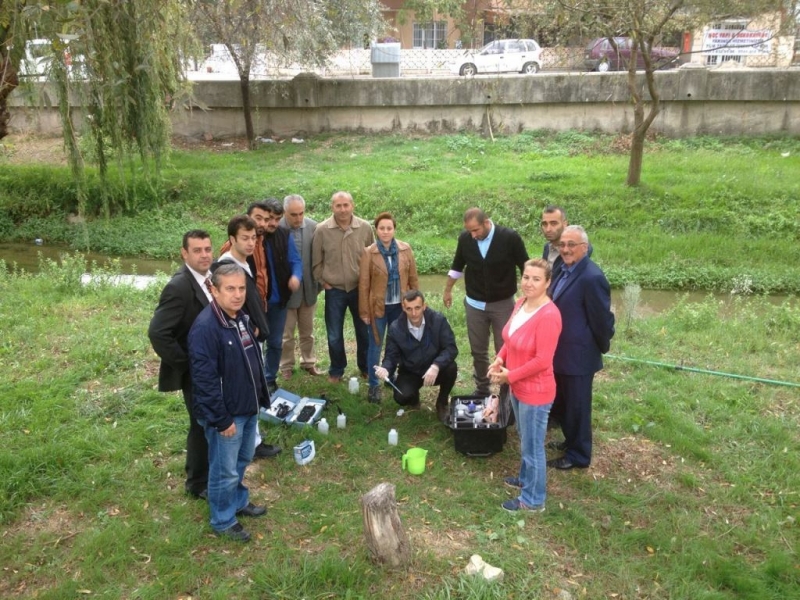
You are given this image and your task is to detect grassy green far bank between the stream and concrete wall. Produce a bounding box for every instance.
[0,131,800,293]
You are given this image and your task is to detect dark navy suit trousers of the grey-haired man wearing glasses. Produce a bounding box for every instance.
[554,373,594,467]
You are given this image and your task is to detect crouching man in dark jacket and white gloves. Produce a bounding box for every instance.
[375,290,458,422]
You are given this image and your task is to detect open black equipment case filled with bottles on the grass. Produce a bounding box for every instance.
[447,396,511,457]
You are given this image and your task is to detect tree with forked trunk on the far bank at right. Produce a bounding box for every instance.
[540,0,797,186]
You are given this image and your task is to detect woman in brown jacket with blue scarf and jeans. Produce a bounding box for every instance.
[358,212,419,403]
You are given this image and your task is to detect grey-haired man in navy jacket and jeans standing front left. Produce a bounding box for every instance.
[189,264,269,542]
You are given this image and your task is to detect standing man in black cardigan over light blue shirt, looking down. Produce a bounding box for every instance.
[443,208,528,396]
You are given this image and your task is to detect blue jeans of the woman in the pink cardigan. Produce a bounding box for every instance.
[509,391,553,507]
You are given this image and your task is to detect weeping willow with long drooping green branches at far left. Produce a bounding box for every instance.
[0,0,185,214]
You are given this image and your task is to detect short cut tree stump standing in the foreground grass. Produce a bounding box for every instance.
[361,483,411,567]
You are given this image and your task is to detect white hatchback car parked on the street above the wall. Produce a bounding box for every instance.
[450,40,542,75]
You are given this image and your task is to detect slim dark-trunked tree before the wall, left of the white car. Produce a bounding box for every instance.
[194,0,383,147]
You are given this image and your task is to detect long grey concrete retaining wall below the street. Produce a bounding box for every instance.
[11,69,800,138]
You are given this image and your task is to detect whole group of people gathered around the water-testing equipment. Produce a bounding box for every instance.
[148,191,614,541]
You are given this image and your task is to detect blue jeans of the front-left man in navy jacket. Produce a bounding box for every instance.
[198,415,258,531]
